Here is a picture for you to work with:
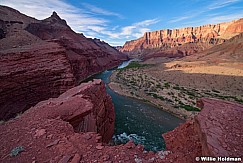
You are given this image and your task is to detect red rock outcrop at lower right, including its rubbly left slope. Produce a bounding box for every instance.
[163,98,243,162]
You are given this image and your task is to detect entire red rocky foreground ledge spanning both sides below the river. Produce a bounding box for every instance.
[0,83,243,163]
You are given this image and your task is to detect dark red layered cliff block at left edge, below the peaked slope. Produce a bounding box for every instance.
[0,43,75,119]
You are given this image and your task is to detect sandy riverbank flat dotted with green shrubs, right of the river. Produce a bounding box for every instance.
[108,60,242,119]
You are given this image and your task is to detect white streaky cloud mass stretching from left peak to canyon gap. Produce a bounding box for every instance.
[1,0,159,45]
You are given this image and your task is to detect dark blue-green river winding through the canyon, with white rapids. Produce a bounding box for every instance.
[93,61,184,151]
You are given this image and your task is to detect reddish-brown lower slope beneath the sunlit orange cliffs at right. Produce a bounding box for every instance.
[144,33,243,60]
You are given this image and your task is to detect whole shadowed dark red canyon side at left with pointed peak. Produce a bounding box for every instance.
[0,6,127,119]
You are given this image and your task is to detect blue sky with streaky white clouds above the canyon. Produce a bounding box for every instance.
[0,0,243,46]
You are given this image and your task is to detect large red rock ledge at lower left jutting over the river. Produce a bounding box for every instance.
[0,80,115,162]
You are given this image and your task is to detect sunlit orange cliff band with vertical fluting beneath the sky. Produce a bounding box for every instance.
[119,19,243,58]
